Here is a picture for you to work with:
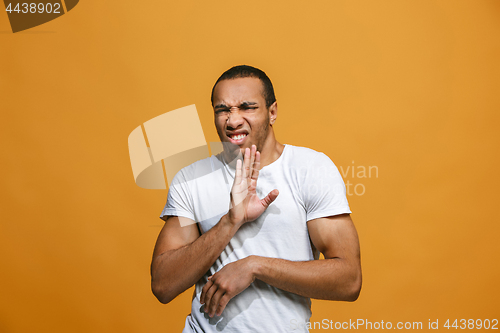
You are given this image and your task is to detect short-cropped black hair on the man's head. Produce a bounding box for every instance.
[210,65,276,108]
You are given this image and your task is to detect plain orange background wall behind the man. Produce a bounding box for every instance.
[0,0,500,332]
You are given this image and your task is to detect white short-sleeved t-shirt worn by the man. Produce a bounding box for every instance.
[161,145,351,333]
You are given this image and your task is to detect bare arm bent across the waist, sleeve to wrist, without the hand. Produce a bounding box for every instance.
[254,215,361,301]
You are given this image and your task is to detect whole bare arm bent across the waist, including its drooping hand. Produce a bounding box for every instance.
[201,215,361,316]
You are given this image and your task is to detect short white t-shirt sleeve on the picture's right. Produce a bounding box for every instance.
[302,153,351,221]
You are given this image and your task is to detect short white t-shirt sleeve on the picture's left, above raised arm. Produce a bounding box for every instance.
[160,170,195,221]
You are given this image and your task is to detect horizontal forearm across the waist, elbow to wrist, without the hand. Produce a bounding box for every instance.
[252,256,361,301]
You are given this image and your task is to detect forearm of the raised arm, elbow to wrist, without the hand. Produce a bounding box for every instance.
[151,215,239,303]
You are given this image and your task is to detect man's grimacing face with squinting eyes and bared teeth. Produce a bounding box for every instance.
[213,77,273,153]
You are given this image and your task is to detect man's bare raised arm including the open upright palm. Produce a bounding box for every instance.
[151,146,278,303]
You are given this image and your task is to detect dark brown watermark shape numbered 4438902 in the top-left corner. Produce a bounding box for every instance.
[4,0,79,33]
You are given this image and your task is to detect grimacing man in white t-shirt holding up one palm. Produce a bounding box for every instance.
[151,66,361,332]
